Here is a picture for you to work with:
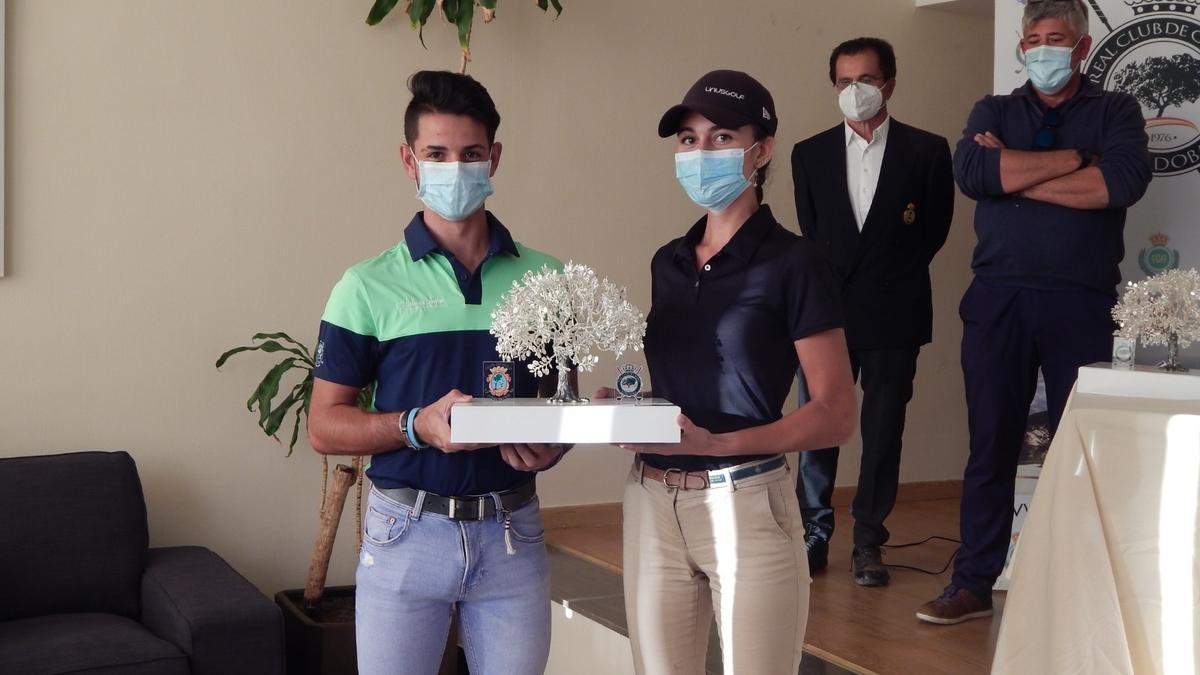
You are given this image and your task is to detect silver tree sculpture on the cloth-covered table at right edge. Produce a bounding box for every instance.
[1112,269,1200,372]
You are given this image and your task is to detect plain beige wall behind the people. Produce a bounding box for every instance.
[0,0,991,591]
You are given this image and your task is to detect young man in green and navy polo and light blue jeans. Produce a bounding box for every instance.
[308,71,563,675]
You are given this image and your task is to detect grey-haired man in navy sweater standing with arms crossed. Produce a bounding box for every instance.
[917,0,1151,623]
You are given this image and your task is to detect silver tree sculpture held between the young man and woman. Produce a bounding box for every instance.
[492,262,646,404]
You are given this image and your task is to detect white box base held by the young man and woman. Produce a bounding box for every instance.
[450,399,679,443]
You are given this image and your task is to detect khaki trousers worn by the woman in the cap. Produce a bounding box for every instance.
[623,460,810,675]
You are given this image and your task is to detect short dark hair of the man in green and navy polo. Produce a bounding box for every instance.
[404,71,500,147]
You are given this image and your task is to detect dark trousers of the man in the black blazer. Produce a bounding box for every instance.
[796,347,920,546]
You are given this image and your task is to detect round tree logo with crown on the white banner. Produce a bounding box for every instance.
[1084,0,1200,176]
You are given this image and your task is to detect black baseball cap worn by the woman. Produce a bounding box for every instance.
[659,71,779,138]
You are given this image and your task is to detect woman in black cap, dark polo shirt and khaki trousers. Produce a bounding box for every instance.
[604,71,856,675]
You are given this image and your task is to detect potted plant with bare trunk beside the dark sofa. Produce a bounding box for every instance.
[216,333,374,675]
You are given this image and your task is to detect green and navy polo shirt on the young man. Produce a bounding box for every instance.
[314,213,563,496]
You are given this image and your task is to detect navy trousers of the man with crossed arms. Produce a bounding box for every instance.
[953,277,1115,596]
